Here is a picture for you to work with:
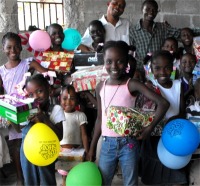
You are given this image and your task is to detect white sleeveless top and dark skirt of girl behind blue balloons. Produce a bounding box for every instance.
[140,80,188,185]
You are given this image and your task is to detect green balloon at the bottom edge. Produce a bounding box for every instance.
[66,162,102,186]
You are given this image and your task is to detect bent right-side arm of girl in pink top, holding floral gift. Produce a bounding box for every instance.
[128,79,169,140]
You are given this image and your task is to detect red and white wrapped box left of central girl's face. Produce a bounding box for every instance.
[72,65,108,92]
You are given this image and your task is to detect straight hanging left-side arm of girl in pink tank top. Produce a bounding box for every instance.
[88,82,103,161]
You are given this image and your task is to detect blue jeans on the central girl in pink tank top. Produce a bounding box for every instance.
[99,136,139,186]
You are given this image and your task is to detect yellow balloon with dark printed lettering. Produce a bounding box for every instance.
[23,123,60,166]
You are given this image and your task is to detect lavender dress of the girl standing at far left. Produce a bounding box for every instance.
[0,57,33,140]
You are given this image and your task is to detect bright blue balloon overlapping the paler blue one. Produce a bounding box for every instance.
[162,119,199,156]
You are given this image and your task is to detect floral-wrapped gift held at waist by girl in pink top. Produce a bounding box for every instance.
[106,106,154,136]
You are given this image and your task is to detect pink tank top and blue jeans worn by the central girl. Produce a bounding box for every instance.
[99,80,139,185]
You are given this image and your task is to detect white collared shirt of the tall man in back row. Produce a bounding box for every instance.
[81,15,130,47]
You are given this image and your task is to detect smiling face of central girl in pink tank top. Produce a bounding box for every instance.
[104,47,128,79]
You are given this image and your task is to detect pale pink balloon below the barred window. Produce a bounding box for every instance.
[29,30,51,52]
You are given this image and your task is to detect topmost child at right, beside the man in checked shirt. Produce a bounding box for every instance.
[179,27,195,54]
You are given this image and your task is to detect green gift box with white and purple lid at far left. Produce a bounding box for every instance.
[0,95,38,124]
